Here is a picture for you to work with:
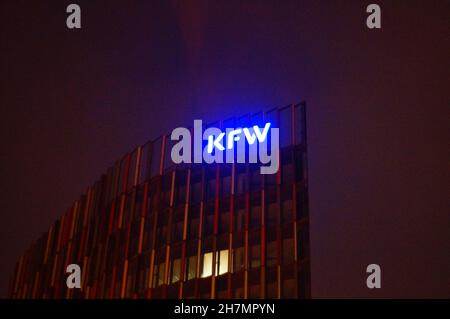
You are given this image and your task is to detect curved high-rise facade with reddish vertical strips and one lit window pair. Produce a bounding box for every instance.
[10,103,310,299]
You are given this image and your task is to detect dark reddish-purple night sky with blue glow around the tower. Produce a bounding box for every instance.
[0,0,450,298]
